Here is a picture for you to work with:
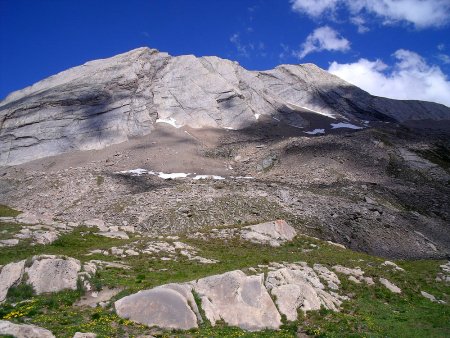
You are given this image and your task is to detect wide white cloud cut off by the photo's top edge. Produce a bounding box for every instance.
[291,0,450,28]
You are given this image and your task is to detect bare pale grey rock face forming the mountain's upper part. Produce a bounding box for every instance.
[0,48,450,165]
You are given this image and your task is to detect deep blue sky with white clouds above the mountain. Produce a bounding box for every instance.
[0,0,450,106]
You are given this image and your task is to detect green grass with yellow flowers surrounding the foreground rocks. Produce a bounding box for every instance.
[0,224,450,337]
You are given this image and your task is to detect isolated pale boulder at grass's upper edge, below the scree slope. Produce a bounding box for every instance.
[241,220,297,246]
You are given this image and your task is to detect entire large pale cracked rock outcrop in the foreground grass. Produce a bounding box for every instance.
[115,263,348,331]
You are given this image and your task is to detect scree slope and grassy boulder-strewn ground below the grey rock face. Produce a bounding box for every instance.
[0,124,450,337]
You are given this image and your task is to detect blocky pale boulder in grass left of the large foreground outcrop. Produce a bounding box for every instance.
[25,255,81,294]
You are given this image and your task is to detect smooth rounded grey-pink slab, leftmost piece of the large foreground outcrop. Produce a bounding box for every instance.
[114,285,198,330]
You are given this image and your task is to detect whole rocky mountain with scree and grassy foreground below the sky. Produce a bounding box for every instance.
[0,48,450,338]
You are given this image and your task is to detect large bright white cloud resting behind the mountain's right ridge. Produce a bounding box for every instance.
[328,49,450,107]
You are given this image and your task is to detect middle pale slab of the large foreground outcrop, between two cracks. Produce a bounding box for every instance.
[193,270,281,331]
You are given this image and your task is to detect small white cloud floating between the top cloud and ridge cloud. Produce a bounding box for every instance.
[294,26,350,59]
